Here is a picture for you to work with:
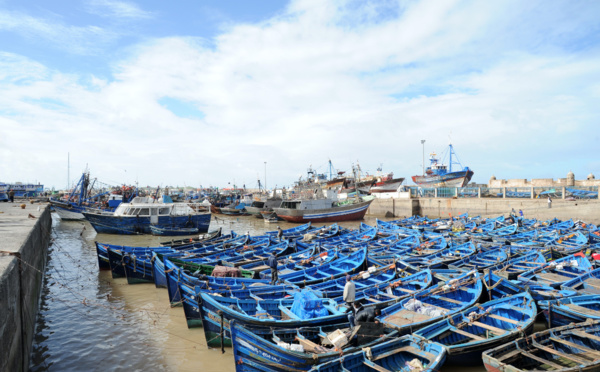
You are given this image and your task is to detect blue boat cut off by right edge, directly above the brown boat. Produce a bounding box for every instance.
[539,294,600,328]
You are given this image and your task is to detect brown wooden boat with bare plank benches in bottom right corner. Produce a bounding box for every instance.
[482,322,600,372]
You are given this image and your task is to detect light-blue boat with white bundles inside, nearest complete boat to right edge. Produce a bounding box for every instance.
[518,254,593,288]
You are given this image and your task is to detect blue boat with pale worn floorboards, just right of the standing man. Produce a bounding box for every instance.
[378,271,482,334]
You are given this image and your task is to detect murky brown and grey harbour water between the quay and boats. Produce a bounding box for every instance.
[30,215,492,372]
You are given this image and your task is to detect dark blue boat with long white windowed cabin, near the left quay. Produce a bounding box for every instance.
[83,196,211,235]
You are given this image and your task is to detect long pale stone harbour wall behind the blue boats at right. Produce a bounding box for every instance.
[367,198,600,224]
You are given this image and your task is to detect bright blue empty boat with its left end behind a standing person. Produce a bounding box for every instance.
[260,248,367,287]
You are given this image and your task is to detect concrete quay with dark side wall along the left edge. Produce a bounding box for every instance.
[0,200,52,371]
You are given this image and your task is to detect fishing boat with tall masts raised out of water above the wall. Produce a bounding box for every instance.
[412,144,473,187]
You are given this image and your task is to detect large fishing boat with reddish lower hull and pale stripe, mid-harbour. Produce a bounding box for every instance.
[273,196,375,223]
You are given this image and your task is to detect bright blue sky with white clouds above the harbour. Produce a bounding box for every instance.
[0,0,600,189]
